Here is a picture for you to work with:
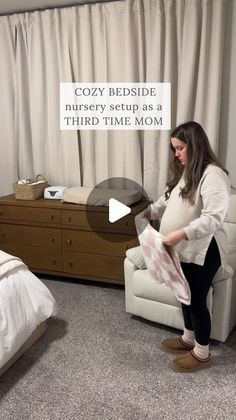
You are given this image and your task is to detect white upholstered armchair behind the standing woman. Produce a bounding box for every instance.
[124,195,236,342]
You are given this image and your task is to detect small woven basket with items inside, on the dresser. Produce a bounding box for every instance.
[13,175,48,200]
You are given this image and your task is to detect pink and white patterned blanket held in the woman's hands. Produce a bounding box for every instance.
[135,211,191,305]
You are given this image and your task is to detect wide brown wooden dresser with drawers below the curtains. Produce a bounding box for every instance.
[0,195,148,284]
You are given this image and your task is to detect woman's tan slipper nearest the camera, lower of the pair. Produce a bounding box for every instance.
[171,350,212,373]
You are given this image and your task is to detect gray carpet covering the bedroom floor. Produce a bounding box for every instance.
[0,279,236,420]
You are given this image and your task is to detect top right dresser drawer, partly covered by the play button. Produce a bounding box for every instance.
[62,210,136,234]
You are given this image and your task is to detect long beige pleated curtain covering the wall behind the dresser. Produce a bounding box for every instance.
[0,0,226,199]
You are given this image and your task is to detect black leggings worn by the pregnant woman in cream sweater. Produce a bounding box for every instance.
[181,237,221,346]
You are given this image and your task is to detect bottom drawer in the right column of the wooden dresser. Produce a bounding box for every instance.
[63,251,124,283]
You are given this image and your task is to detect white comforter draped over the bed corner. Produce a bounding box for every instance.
[0,251,56,368]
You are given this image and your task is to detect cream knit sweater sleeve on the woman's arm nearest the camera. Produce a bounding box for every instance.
[183,165,230,240]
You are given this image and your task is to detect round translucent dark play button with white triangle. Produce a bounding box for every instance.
[85,177,150,243]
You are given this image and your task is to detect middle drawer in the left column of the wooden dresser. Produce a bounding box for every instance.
[0,223,61,252]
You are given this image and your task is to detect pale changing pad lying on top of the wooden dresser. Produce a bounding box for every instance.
[63,187,142,206]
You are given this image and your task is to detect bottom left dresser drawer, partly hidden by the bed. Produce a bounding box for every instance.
[1,245,62,271]
